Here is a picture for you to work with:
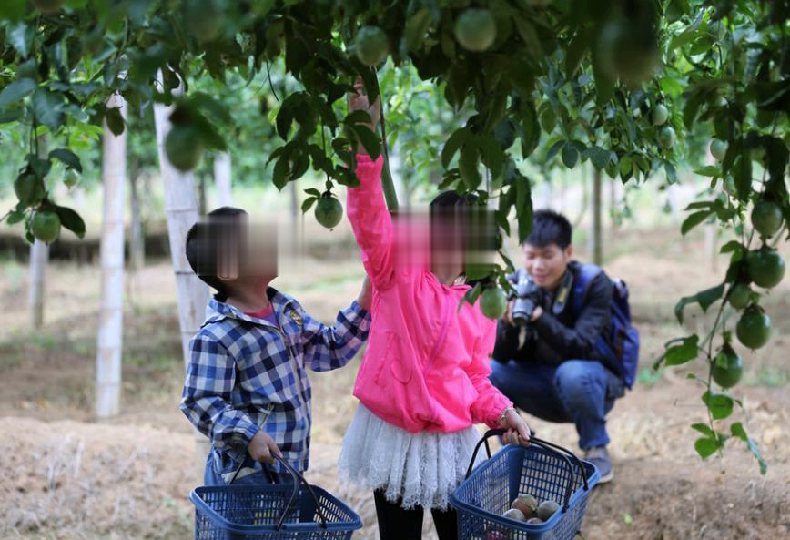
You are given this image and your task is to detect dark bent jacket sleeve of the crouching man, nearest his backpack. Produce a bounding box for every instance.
[534,273,612,360]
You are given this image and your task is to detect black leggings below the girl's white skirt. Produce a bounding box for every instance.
[373,490,458,540]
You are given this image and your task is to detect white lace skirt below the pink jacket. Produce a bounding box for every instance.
[338,404,485,509]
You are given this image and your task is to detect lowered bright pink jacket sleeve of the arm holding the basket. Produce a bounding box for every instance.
[467,314,513,429]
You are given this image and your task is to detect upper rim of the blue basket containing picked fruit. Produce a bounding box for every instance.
[450,444,601,533]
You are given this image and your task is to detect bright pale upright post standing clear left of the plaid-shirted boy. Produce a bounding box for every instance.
[96,94,128,418]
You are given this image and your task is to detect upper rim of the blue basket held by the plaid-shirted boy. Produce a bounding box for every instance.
[188,484,362,534]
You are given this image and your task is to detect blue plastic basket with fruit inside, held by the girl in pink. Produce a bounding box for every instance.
[450,430,600,540]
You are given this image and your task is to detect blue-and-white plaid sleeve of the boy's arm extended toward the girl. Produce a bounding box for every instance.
[299,300,370,371]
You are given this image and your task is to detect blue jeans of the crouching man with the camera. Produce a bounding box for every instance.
[490,360,623,450]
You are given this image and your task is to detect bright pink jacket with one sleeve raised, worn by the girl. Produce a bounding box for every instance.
[347,154,512,433]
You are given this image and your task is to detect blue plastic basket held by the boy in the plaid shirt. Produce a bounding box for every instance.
[189,459,362,540]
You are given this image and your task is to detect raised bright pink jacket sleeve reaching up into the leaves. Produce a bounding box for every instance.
[346,154,393,289]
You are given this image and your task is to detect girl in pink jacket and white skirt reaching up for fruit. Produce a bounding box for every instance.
[339,83,530,540]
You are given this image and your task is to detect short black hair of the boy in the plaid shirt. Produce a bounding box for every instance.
[186,206,247,302]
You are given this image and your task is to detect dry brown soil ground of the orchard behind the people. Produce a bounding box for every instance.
[0,226,790,540]
